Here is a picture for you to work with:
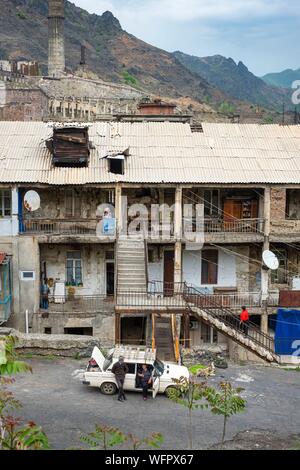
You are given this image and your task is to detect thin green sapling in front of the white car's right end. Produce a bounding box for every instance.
[168,377,208,450]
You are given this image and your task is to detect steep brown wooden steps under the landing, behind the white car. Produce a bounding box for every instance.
[154,315,176,362]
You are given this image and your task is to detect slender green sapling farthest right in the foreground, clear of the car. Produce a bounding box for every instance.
[206,382,247,446]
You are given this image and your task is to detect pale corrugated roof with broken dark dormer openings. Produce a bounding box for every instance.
[0,122,300,185]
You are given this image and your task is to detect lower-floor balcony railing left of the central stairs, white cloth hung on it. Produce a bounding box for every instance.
[40,294,115,315]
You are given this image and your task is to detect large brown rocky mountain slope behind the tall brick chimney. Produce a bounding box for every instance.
[0,0,224,102]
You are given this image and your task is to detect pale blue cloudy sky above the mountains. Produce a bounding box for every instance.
[72,0,300,75]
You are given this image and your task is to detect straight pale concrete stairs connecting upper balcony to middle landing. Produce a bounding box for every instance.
[117,236,147,295]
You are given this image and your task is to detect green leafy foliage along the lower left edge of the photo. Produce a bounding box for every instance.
[0,336,49,450]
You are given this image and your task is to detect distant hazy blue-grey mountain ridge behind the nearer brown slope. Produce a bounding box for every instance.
[173,51,290,110]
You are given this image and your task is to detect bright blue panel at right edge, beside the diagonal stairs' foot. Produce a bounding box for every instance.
[275,308,300,356]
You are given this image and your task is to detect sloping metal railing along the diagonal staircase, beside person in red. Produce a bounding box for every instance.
[183,285,274,353]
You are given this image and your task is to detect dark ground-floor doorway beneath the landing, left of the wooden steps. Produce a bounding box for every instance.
[121,317,147,346]
